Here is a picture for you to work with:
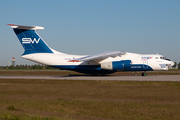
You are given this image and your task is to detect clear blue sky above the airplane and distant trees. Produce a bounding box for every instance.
[0,0,180,66]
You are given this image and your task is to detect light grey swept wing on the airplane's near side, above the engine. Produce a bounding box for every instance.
[69,51,126,62]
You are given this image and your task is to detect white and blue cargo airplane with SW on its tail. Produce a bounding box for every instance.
[7,24,174,76]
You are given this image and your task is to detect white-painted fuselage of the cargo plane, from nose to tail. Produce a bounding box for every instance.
[22,52,173,71]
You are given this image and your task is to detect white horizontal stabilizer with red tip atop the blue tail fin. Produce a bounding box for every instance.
[7,24,44,30]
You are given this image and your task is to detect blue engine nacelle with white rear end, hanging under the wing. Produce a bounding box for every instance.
[101,60,131,70]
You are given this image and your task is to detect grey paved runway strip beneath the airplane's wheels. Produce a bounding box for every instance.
[0,75,180,82]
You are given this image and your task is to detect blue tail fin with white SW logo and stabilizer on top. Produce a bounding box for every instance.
[8,24,53,55]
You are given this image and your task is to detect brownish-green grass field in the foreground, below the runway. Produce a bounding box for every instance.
[0,79,180,120]
